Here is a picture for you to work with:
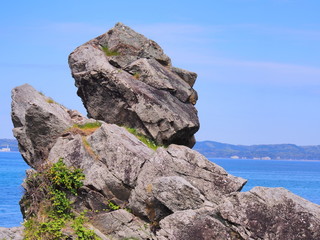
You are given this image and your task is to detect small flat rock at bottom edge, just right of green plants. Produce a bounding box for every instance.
[92,209,154,240]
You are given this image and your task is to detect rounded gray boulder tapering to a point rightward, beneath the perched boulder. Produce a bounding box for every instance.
[129,145,246,221]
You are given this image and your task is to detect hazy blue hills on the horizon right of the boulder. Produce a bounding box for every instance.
[193,141,320,160]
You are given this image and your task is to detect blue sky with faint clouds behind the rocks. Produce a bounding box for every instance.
[0,0,320,145]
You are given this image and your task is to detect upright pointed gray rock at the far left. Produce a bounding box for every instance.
[12,84,73,168]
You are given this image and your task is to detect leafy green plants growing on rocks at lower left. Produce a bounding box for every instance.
[23,159,98,240]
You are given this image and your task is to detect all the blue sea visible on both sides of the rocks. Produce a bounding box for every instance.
[0,152,320,227]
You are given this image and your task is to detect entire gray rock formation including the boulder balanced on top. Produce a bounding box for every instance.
[6,24,320,240]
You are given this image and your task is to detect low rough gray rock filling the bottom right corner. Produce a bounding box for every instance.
[157,187,320,240]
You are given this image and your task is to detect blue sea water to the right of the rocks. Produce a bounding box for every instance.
[210,159,320,204]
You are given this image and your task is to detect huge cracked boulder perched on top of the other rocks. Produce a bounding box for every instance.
[69,23,199,147]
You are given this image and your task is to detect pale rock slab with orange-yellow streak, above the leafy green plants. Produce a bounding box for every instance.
[48,123,154,202]
